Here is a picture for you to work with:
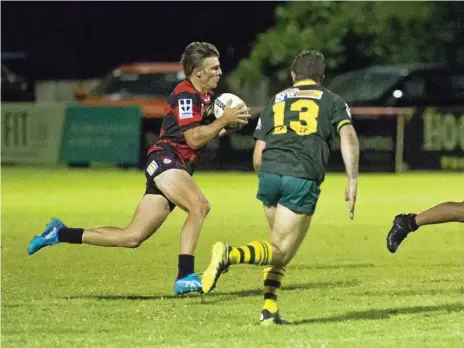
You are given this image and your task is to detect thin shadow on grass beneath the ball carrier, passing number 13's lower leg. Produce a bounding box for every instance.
[64,280,359,304]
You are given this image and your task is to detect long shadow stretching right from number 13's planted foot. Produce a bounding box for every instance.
[292,303,464,325]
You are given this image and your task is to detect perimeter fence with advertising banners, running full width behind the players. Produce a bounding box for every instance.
[1,103,464,172]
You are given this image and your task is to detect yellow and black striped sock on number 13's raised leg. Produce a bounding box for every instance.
[229,241,272,265]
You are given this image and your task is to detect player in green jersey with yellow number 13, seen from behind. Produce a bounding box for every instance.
[202,51,359,324]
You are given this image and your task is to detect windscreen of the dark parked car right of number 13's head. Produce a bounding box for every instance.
[327,71,403,103]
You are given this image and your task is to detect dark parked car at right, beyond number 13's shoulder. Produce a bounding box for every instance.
[327,64,464,107]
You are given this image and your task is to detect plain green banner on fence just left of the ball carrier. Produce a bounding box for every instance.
[59,105,141,164]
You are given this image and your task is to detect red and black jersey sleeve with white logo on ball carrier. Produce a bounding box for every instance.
[171,92,202,132]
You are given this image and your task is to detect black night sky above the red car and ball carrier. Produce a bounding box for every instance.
[1,1,281,79]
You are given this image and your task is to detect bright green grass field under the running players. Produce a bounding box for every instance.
[1,167,464,347]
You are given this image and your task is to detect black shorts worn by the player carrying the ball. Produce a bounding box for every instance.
[144,144,195,211]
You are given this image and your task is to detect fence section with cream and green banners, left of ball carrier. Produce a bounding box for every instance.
[1,103,141,165]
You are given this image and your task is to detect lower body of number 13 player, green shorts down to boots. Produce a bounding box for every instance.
[203,173,320,325]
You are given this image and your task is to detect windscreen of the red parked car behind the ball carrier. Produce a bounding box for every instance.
[90,70,185,98]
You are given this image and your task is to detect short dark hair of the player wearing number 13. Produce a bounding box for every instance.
[292,51,325,82]
